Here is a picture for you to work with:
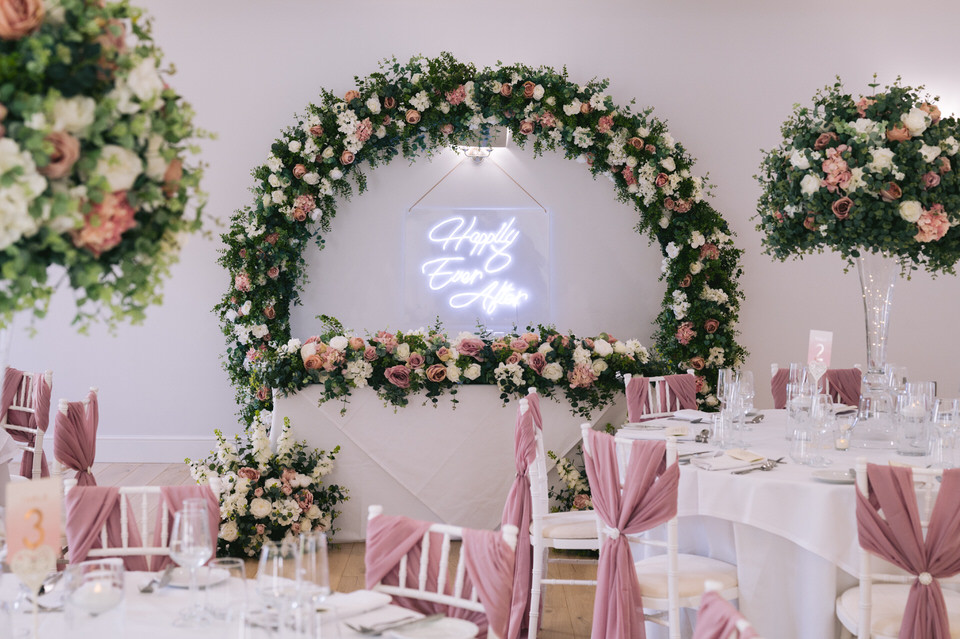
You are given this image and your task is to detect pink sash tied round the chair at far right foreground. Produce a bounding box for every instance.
[857,464,960,639]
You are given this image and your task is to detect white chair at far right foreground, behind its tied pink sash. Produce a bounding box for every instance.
[837,458,960,639]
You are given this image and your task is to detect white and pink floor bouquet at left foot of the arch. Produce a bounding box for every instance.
[186,412,347,557]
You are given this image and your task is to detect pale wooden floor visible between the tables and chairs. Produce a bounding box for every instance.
[18,463,596,639]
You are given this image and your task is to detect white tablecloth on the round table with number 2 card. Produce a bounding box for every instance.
[636,410,927,639]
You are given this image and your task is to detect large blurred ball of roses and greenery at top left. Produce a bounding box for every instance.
[0,0,205,326]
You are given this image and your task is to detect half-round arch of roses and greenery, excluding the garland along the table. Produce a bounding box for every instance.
[216,53,744,428]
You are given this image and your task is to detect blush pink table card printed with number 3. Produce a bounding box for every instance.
[6,478,62,592]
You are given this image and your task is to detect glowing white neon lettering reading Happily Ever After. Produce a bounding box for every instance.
[420,215,530,315]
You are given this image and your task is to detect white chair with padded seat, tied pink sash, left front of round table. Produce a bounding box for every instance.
[580,424,739,639]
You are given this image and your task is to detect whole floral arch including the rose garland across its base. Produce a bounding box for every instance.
[216,53,744,422]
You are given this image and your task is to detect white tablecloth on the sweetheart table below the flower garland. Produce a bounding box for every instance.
[272,386,626,541]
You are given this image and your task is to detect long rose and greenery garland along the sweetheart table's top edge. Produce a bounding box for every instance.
[246,317,668,416]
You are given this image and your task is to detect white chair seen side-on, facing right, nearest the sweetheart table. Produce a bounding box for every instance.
[520,399,600,639]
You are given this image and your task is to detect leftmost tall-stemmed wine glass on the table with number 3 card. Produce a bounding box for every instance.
[170,500,213,627]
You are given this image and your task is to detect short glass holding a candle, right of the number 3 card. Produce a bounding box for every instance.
[63,559,123,635]
